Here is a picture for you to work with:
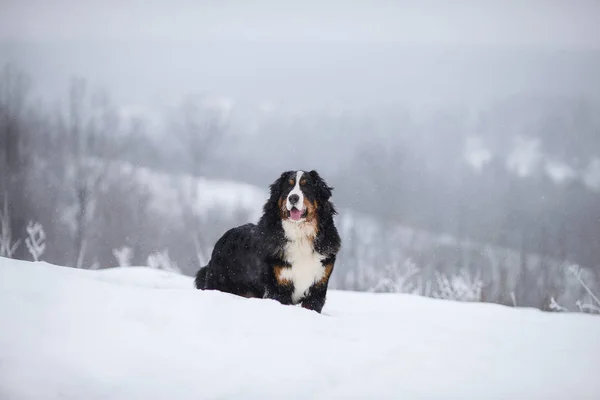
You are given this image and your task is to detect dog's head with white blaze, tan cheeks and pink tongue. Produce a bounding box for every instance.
[269,170,333,223]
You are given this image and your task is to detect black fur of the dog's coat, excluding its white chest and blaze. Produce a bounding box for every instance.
[196,171,341,312]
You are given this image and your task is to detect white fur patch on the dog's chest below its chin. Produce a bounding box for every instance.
[281,221,325,303]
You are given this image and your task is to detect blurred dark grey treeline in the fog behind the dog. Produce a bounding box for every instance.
[0,63,600,308]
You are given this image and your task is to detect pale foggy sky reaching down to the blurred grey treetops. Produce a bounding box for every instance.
[0,0,600,118]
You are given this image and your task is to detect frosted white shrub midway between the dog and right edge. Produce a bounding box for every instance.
[433,270,483,301]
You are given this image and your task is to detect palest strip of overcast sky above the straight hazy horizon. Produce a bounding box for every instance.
[0,0,600,49]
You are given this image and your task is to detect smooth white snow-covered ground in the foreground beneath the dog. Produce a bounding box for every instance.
[0,258,600,400]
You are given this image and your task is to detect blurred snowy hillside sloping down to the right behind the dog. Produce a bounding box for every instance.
[43,158,600,311]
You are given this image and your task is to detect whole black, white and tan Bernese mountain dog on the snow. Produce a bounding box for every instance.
[195,170,341,313]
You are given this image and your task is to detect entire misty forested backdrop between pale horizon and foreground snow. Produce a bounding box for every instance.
[0,40,600,313]
